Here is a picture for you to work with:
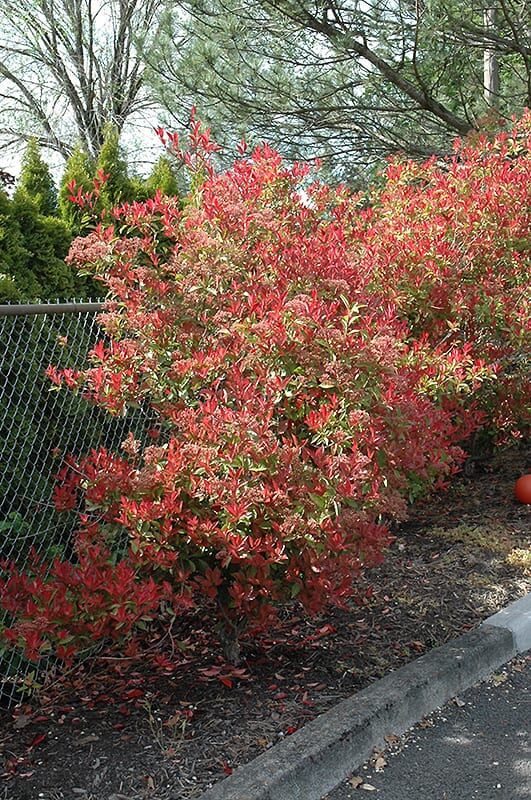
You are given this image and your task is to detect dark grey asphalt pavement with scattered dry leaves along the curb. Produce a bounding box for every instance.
[323,651,531,800]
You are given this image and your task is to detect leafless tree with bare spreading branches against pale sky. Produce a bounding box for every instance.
[0,0,165,158]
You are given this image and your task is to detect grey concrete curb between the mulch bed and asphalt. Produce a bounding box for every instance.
[200,594,531,800]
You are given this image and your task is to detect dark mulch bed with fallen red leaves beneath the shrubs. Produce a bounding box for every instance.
[0,445,531,800]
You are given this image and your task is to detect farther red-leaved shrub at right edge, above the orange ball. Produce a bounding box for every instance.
[349,111,531,435]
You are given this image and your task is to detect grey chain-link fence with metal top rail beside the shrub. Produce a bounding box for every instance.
[0,302,153,705]
